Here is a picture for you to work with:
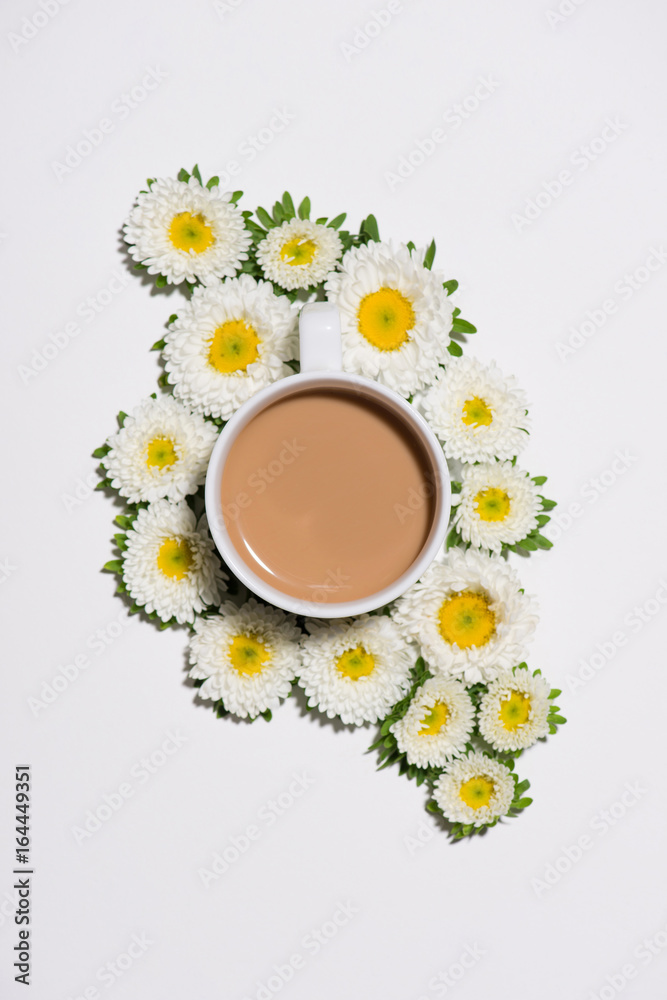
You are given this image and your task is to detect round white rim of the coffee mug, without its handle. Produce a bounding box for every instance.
[204,370,451,619]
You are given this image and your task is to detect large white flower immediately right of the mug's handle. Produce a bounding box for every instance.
[325,243,453,397]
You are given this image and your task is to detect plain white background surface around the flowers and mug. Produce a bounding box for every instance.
[0,0,667,1000]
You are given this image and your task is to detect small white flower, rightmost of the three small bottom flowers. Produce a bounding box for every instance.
[478,667,551,750]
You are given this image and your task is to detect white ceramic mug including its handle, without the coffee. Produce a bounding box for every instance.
[205,302,451,618]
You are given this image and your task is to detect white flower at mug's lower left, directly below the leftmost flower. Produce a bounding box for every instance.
[122,500,227,624]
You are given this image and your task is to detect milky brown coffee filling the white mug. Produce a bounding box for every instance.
[221,387,435,602]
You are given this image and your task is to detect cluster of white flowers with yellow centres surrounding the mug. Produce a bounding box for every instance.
[99,176,563,831]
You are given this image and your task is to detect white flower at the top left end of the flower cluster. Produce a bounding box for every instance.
[124,177,251,285]
